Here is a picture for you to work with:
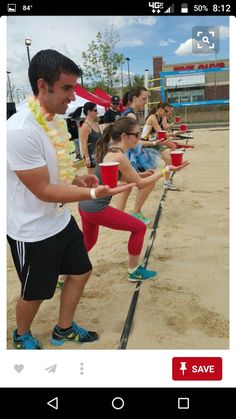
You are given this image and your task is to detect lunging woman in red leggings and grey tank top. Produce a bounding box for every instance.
[79,117,188,282]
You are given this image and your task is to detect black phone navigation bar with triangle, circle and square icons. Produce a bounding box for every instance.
[0,388,236,419]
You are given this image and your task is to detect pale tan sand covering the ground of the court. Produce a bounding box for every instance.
[7,129,229,350]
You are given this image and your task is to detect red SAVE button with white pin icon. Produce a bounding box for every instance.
[172,357,222,381]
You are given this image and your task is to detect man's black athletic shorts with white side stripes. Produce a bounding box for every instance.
[7,217,92,300]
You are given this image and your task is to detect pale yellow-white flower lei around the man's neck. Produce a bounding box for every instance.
[28,96,76,184]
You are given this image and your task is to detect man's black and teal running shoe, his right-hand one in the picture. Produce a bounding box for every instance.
[50,322,99,346]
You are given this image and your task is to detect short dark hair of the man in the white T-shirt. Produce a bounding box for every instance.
[28,49,81,95]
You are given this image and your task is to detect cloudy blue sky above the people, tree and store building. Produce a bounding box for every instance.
[7,15,229,98]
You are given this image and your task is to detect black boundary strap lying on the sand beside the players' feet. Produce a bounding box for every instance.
[118,172,175,349]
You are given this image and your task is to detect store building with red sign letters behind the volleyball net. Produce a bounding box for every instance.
[153,57,229,103]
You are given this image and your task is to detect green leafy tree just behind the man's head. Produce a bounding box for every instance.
[82,25,125,94]
